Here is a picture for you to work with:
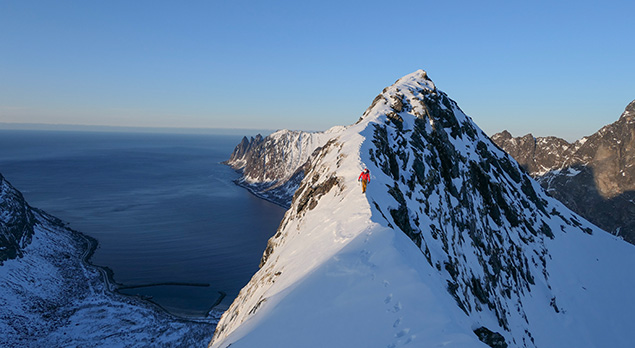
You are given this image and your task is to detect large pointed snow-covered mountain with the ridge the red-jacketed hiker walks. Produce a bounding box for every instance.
[210,70,635,348]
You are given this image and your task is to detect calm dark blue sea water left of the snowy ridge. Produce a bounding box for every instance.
[0,130,284,315]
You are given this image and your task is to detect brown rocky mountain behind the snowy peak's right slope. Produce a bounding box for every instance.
[492,101,635,244]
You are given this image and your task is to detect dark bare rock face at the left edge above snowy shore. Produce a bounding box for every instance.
[0,174,35,265]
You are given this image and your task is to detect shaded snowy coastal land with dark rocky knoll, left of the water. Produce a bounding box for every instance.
[0,175,215,347]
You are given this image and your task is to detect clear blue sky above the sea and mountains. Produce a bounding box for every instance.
[0,0,635,140]
